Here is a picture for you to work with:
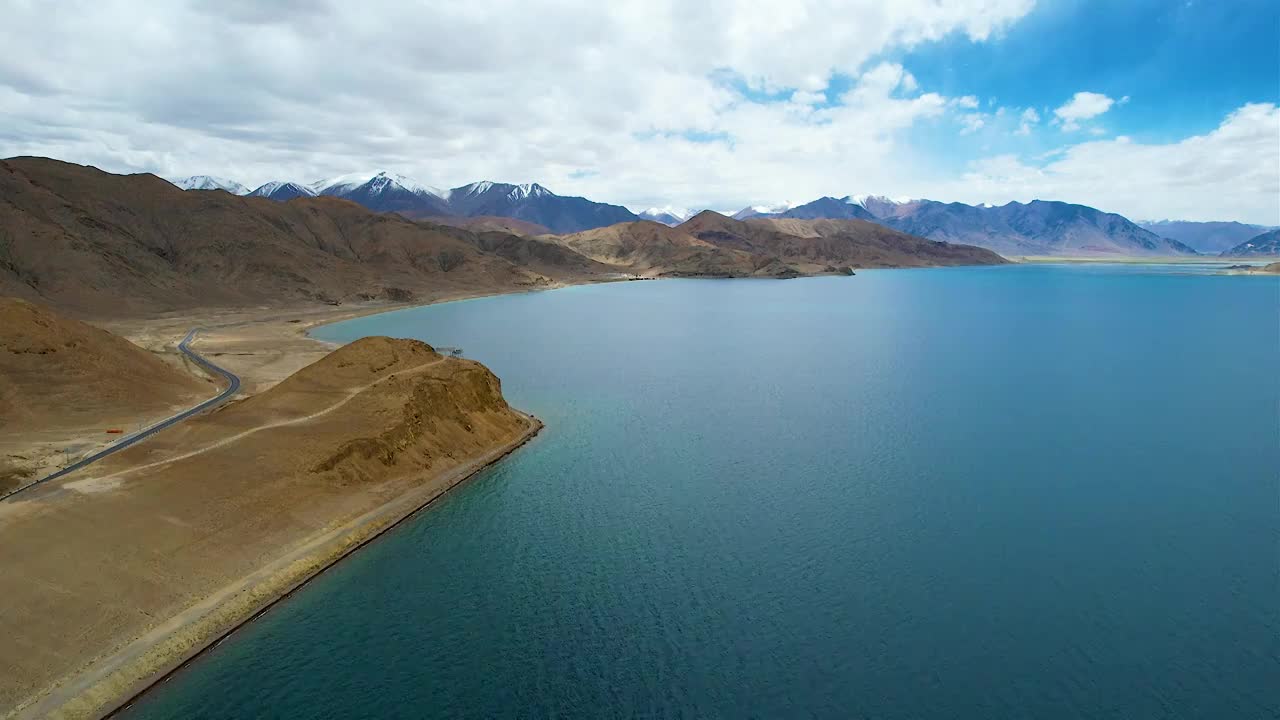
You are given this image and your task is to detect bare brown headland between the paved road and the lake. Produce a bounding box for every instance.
[0,319,540,717]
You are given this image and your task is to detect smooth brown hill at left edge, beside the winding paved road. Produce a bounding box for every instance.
[0,297,214,434]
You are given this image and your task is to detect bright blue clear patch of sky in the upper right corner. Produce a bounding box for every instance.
[890,0,1280,172]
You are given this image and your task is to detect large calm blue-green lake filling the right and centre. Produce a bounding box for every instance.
[125,265,1280,719]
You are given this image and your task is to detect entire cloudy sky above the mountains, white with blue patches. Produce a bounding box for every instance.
[0,0,1280,225]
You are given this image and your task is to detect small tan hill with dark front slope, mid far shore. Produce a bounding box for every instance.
[556,220,797,277]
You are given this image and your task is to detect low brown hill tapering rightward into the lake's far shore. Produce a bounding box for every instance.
[678,210,1006,273]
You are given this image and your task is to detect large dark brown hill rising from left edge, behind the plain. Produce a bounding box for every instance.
[0,158,604,316]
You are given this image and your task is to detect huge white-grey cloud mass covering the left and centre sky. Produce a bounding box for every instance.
[0,0,1274,219]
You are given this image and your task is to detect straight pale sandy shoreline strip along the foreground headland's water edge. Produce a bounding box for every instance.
[15,410,544,719]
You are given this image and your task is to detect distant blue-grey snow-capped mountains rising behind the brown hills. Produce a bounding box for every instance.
[170,170,1239,255]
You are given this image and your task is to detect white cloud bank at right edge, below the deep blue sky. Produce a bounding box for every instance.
[933,104,1280,224]
